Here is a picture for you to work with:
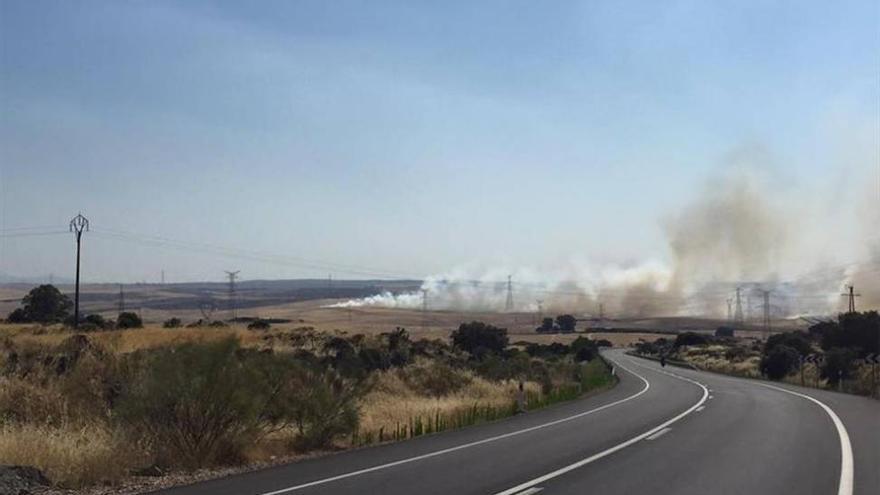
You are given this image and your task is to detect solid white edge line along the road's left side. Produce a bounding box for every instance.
[253,354,648,495]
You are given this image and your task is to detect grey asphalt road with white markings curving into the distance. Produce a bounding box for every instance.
[155,351,880,495]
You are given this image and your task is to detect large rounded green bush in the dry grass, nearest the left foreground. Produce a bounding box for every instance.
[117,339,280,468]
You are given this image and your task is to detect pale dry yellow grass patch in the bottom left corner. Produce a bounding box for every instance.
[0,424,138,488]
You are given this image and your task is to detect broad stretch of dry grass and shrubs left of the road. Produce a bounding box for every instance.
[0,286,613,488]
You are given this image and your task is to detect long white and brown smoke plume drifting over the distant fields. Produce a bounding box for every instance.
[334,149,880,317]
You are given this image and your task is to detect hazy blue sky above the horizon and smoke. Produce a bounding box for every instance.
[0,0,880,282]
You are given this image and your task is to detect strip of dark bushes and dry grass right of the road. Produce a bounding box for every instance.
[635,311,880,397]
